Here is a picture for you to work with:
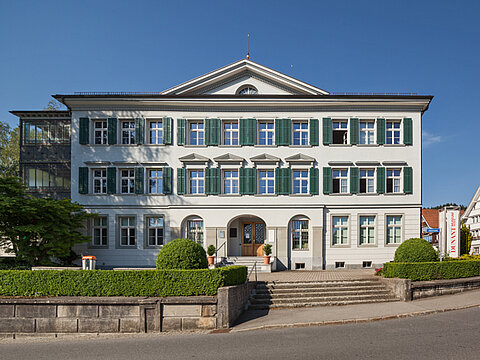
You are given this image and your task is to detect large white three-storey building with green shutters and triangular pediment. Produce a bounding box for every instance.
[54,59,432,269]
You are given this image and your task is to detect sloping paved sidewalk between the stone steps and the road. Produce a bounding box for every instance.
[231,290,480,332]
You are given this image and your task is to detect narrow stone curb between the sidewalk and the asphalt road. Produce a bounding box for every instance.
[230,304,480,333]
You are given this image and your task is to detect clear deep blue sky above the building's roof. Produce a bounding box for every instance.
[0,0,480,206]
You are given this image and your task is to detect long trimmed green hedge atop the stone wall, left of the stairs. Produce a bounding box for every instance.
[0,266,247,297]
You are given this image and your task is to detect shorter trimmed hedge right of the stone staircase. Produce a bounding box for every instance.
[382,260,480,281]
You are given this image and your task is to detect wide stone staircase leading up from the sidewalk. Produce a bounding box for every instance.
[249,278,397,310]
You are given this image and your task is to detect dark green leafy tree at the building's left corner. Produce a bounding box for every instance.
[0,176,93,265]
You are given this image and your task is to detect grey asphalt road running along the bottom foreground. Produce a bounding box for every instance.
[0,308,480,360]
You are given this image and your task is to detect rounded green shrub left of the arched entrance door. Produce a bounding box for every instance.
[157,239,208,270]
